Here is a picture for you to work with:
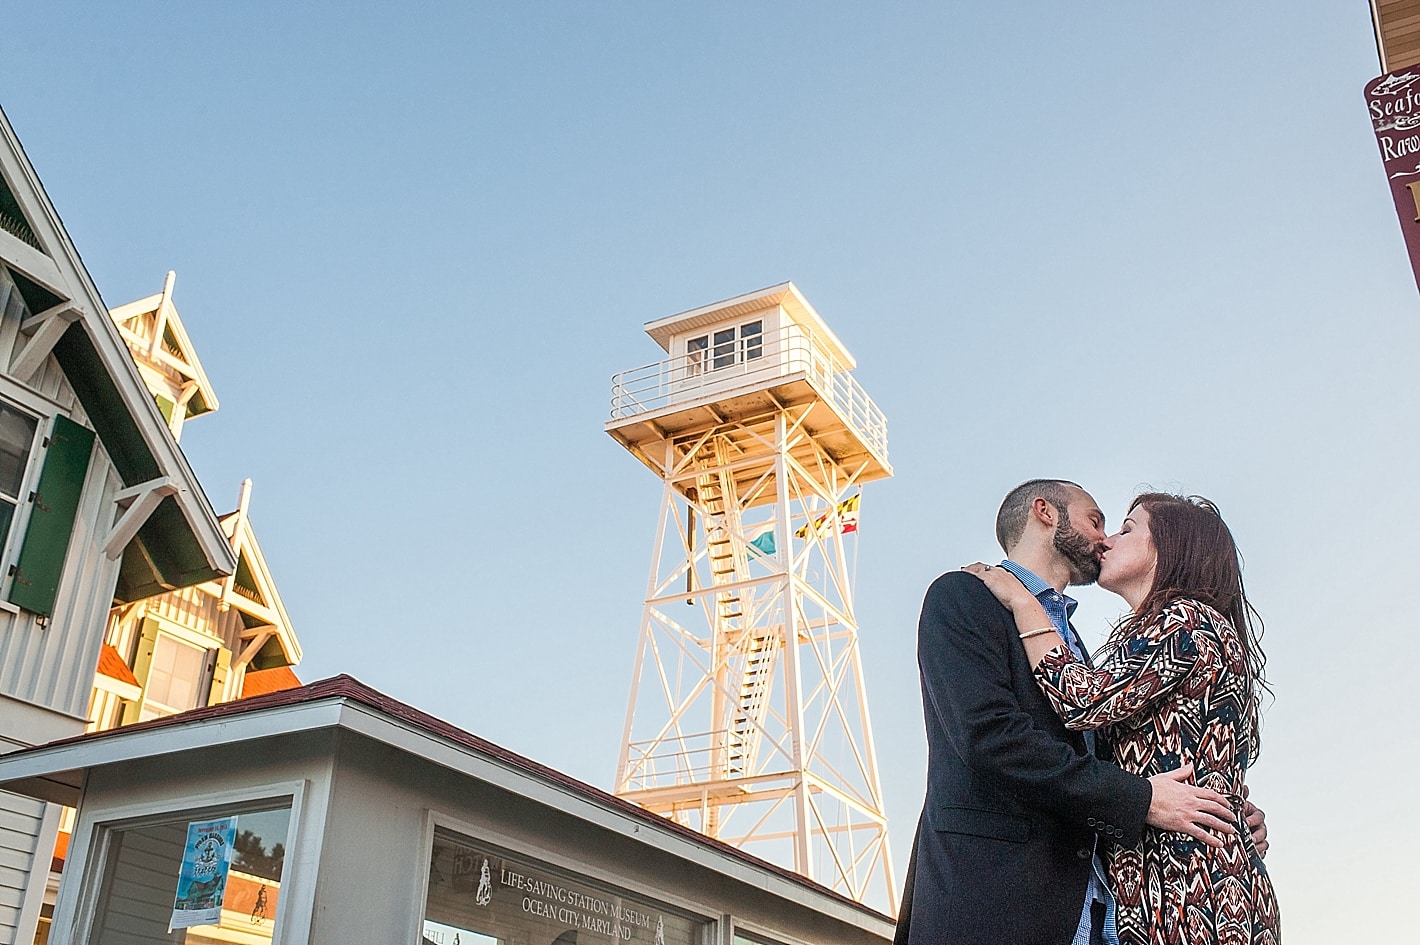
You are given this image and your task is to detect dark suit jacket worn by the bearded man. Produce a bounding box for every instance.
[896,571,1152,945]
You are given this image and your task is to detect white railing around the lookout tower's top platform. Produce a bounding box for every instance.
[612,325,888,459]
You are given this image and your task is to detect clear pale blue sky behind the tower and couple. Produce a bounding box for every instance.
[0,0,1420,945]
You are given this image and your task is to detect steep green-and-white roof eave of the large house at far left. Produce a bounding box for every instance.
[0,103,236,601]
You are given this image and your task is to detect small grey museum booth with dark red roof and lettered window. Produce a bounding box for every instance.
[0,676,893,945]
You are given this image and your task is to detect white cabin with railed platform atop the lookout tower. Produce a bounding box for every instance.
[606,283,892,506]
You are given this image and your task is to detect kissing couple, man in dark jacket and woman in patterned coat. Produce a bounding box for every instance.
[895,479,1281,945]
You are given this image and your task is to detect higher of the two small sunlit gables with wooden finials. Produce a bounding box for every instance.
[109,273,217,435]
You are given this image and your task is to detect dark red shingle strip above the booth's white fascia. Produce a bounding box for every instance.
[16,674,893,922]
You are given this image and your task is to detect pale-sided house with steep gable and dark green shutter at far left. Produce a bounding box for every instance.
[0,105,237,945]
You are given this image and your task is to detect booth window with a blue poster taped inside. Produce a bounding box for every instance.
[88,804,291,945]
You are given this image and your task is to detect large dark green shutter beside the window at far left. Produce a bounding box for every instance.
[10,416,94,615]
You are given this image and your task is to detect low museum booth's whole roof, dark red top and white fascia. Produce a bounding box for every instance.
[0,675,892,935]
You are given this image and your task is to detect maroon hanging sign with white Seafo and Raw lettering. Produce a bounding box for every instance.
[1366,68,1420,292]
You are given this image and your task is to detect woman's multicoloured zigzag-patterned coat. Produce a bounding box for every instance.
[1035,600,1281,945]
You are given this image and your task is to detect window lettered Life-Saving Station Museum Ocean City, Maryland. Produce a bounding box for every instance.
[423,828,704,945]
